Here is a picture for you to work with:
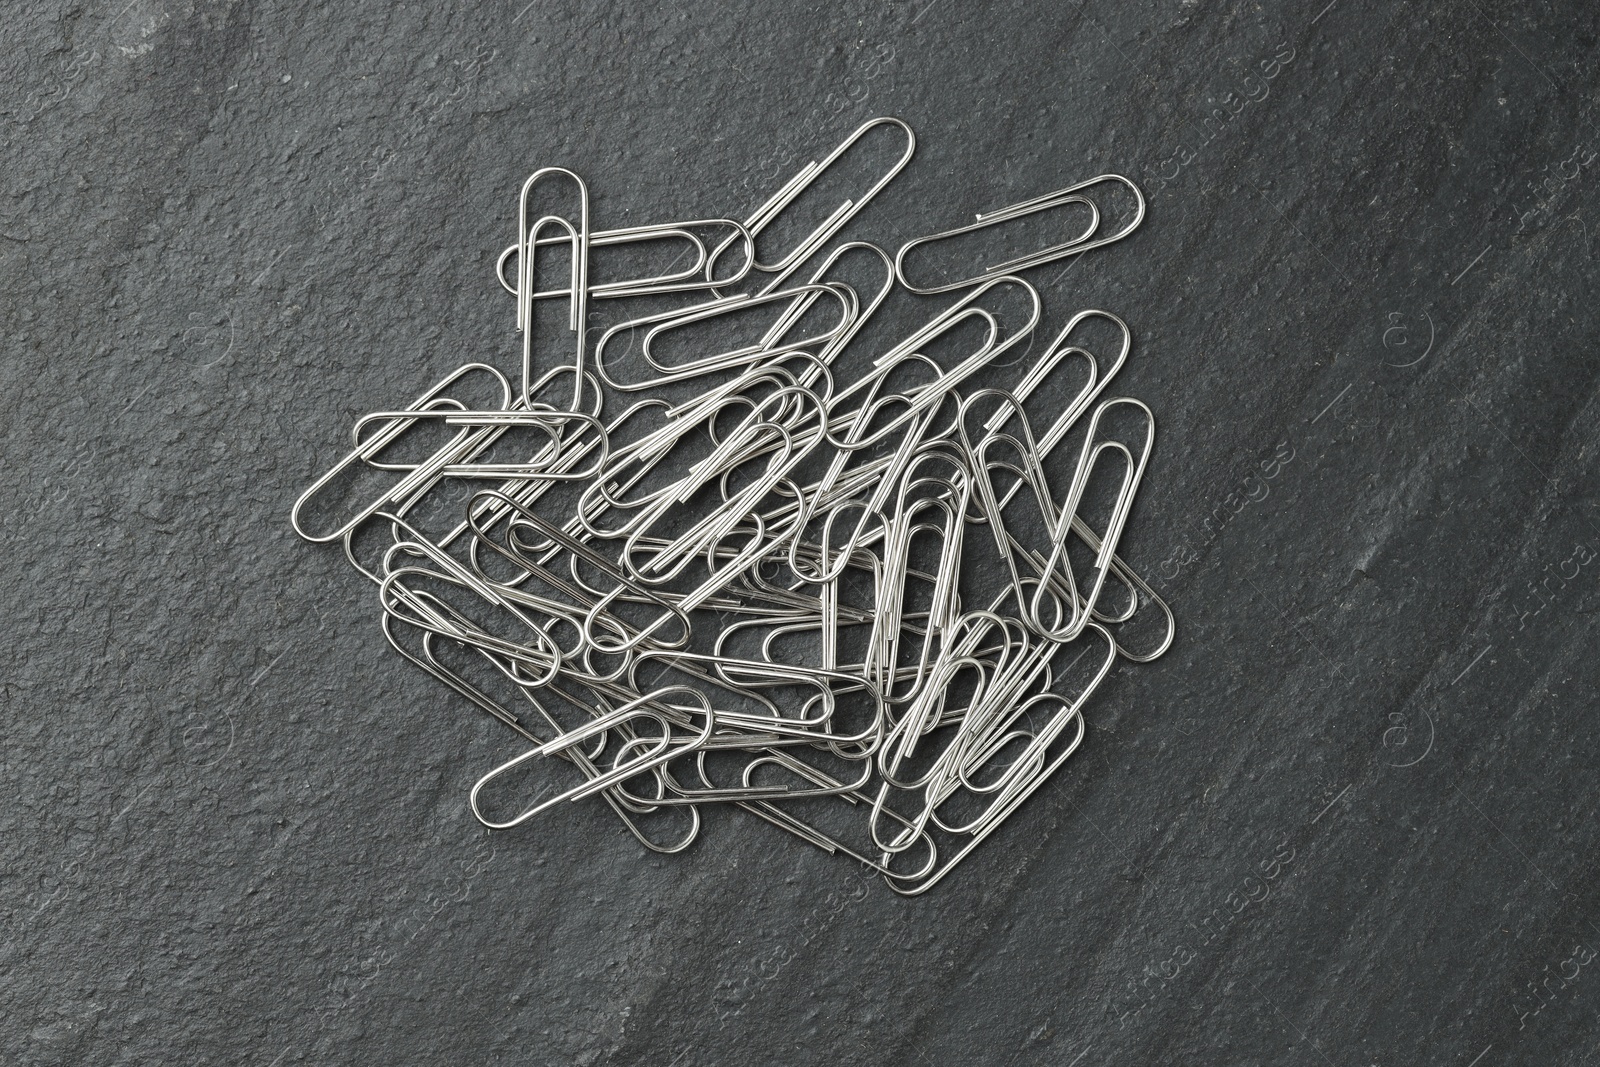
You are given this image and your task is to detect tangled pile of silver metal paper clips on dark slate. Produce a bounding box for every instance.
[293,118,1174,894]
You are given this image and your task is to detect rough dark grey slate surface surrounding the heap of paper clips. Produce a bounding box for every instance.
[0,0,1600,1067]
